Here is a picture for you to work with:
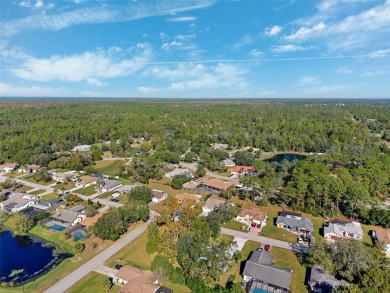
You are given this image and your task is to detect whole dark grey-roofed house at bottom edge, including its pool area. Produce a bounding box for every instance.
[242,249,292,293]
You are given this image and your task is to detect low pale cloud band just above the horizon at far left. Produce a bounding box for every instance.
[0,83,71,97]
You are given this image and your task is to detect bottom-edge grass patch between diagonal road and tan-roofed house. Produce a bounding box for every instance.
[65,272,121,293]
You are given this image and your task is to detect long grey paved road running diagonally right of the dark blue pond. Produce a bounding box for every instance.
[45,219,153,293]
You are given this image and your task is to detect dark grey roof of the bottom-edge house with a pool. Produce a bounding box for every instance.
[243,249,292,289]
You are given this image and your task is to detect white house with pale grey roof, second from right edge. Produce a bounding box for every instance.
[324,220,363,241]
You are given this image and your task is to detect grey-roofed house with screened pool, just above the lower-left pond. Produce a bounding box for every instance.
[42,205,87,231]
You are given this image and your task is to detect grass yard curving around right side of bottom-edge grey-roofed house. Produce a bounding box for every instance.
[270,247,307,292]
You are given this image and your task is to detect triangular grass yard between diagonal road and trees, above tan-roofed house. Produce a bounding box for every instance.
[106,231,156,270]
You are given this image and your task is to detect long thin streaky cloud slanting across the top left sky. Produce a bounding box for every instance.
[0,0,215,37]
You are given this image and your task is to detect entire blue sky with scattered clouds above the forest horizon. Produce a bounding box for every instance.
[0,0,390,98]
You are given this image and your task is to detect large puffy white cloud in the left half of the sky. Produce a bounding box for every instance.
[12,44,152,86]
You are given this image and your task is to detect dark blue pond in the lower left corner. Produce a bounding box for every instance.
[0,231,69,285]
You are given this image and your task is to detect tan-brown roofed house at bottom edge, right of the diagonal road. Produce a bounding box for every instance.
[113,266,161,293]
